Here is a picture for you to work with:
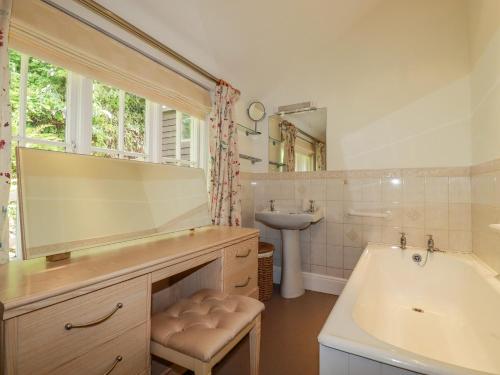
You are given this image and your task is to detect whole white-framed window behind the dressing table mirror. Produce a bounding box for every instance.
[8,50,208,256]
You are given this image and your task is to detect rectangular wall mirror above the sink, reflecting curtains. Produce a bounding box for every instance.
[269,108,326,172]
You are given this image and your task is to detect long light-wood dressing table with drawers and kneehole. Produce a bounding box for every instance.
[0,226,258,375]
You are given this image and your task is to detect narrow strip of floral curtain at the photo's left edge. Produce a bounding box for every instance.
[0,0,12,264]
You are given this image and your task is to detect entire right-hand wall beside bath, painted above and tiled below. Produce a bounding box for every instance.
[469,0,500,272]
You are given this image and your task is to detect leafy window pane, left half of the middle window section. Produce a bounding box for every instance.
[92,81,120,150]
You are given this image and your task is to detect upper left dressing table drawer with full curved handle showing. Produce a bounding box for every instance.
[16,276,149,374]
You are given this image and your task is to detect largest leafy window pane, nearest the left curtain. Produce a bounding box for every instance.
[26,57,67,142]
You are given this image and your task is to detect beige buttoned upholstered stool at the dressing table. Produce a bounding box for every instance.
[151,289,264,375]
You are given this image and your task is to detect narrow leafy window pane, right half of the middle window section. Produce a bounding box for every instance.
[124,93,146,153]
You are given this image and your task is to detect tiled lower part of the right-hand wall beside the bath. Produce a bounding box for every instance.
[471,160,500,273]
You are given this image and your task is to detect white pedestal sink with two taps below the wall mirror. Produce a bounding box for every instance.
[255,208,324,298]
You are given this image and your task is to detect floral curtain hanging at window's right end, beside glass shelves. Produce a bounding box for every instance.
[210,81,241,226]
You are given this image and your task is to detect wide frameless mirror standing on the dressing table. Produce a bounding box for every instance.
[17,148,211,259]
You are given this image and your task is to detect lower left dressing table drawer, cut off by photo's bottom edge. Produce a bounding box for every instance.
[51,323,149,375]
